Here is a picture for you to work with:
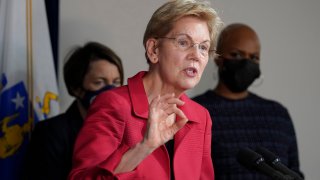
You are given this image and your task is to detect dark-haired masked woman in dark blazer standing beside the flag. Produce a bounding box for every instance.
[22,42,124,180]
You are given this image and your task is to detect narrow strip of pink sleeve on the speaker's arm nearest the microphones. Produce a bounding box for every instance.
[200,110,214,179]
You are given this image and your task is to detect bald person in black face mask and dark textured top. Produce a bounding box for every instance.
[193,24,303,180]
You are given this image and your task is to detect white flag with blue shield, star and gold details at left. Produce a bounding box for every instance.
[0,0,59,180]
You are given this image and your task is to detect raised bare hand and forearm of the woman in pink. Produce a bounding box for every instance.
[114,94,188,173]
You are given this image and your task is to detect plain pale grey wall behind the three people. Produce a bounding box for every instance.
[59,0,320,180]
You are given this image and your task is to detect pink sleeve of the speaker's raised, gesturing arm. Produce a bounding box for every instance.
[69,93,129,180]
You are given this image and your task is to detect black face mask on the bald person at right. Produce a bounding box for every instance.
[219,59,260,92]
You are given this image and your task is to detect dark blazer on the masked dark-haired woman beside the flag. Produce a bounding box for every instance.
[22,101,83,180]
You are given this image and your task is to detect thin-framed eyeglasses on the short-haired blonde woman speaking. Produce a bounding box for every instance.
[158,34,215,57]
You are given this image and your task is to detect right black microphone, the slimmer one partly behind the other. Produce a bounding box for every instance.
[256,147,303,180]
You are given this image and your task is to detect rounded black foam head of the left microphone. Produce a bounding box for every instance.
[237,147,264,169]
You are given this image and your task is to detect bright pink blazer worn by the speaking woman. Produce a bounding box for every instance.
[69,72,214,180]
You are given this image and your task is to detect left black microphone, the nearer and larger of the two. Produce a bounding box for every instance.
[237,148,293,180]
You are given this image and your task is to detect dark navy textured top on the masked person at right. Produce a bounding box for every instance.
[193,91,302,180]
